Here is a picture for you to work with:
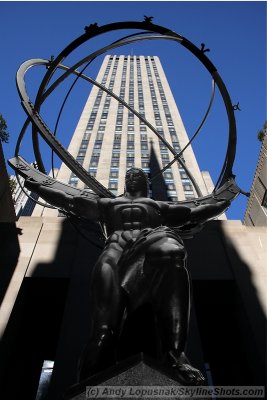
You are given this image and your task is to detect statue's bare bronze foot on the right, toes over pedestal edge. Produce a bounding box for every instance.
[167,350,205,386]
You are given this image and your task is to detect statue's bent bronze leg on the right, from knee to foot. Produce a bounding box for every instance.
[145,238,204,385]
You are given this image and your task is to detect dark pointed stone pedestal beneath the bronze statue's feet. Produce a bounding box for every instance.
[63,353,207,400]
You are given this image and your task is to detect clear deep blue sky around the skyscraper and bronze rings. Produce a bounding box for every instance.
[0,1,266,220]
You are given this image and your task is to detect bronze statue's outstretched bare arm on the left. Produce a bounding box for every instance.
[25,179,99,221]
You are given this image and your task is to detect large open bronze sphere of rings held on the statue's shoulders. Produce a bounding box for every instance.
[9,17,242,220]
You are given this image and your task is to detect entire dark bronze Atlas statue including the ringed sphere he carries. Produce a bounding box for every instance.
[9,17,245,385]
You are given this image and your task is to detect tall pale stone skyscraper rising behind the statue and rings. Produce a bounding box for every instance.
[35,55,216,215]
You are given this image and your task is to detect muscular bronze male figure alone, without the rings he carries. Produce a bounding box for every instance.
[25,168,230,385]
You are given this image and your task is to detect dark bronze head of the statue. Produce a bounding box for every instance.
[125,168,148,197]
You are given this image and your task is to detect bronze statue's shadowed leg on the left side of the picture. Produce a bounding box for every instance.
[78,246,125,381]
